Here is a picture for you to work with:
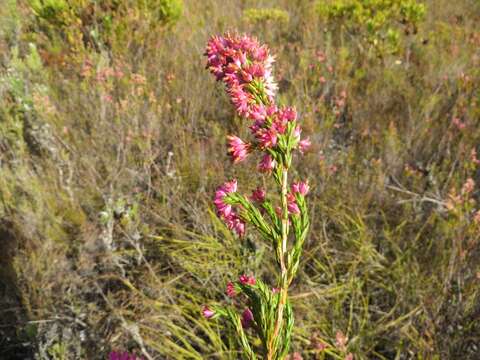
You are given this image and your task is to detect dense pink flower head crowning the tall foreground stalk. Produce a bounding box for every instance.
[205,34,310,165]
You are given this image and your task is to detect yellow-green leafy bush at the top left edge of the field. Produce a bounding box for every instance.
[23,0,183,59]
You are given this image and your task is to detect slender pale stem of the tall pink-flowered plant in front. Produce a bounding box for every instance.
[267,167,289,360]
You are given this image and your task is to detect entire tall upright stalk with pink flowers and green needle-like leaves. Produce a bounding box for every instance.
[203,34,310,360]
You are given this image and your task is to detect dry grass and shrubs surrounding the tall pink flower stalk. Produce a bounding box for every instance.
[0,0,480,360]
